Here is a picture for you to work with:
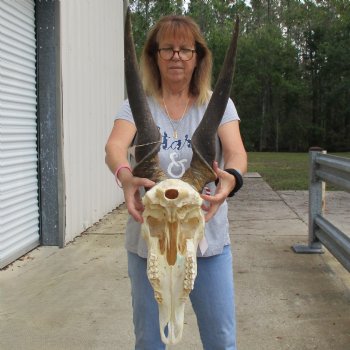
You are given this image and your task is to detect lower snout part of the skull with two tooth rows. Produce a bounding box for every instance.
[147,238,198,345]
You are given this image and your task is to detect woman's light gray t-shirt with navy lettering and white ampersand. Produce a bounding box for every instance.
[115,97,239,258]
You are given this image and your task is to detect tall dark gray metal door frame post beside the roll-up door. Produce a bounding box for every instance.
[35,0,66,248]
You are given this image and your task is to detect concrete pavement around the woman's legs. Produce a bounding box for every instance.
[0,178,350,350]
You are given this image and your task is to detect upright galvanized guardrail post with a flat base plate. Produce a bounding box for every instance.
[293,147,324,254]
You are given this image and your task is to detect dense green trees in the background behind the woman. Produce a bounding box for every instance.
[130,0,350,152]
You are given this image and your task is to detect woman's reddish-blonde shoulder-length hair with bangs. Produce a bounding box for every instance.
[140,15,213,104]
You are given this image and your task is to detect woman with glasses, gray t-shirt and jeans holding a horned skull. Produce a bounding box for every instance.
[106,16,247,350]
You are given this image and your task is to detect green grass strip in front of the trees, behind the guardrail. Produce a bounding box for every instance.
[248,152,350,191]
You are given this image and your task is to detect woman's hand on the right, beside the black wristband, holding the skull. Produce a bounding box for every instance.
[201,161,236,222]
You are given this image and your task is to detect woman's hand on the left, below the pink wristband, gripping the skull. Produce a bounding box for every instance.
[118,169,155,224]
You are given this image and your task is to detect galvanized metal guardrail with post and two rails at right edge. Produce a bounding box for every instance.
[293,148,350,272]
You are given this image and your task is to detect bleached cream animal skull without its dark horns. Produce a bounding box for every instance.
[142,179,204,344]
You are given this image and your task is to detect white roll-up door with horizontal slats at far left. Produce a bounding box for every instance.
[0,0,39,267]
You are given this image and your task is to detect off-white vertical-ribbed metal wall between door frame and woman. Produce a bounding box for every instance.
[60,0,124,242]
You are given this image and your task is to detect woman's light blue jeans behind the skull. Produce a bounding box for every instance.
[128,246,236,350]
